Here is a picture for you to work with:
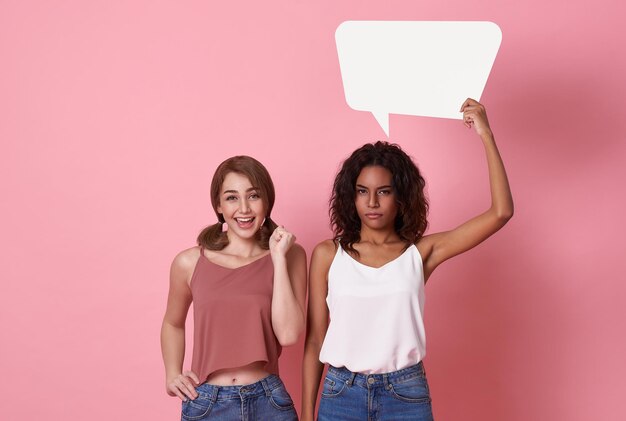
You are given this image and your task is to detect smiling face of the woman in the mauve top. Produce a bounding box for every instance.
[217,172,266,240]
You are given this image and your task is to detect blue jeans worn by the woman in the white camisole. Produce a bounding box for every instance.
[317,362,433,421]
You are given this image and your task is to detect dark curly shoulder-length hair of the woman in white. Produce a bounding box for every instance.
[329,141,428,255]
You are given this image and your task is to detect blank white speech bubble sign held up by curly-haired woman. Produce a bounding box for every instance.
[335,21,502,136]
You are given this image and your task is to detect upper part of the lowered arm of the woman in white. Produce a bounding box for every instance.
[307,240,336,346]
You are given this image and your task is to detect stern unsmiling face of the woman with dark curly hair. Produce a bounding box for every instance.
[354,165,398,230]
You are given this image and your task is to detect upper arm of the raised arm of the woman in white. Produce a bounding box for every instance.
[417,209,509,279]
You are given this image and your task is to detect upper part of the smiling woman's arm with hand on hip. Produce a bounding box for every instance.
[163,249,198,327]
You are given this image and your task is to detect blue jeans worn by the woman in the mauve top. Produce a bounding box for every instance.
[181,374,298,421]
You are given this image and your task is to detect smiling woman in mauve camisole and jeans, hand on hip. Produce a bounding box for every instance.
[161,156,306,421]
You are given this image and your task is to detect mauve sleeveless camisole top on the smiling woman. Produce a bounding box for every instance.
[191,246,282,381]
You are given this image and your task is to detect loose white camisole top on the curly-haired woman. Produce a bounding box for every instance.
[320,245,426,374]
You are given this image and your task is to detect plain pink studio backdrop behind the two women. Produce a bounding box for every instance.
[0,0,626,421]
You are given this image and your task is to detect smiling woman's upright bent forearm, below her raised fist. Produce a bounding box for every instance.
[272,256,304,345]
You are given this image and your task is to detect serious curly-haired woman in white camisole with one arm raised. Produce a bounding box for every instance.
[301,99,513,421]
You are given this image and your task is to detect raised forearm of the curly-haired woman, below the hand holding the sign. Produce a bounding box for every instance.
[480,130,513,218]
